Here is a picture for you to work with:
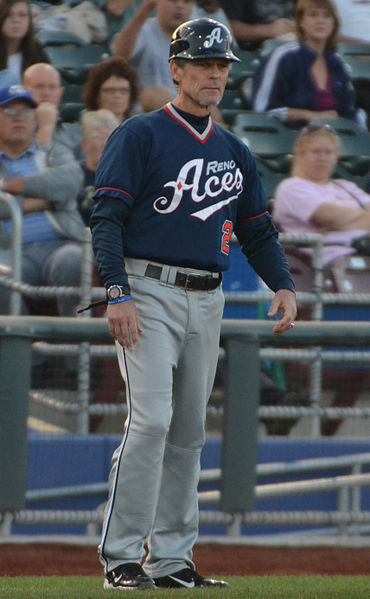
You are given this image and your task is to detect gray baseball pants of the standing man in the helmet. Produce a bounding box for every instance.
[99,259,224,577]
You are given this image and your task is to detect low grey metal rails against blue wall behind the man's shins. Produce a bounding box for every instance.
[0,453,370,537]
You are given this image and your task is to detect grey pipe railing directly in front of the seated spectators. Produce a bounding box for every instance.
[0,193,370,437]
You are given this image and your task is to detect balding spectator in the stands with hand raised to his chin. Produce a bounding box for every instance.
[23,62,81,159]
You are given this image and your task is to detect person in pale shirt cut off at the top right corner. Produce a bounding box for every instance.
[334,0,370,45]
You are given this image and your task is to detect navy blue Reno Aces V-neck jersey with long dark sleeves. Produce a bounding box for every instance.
[91,104,293,296]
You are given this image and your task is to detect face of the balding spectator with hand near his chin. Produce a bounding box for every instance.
[24,66,63,108]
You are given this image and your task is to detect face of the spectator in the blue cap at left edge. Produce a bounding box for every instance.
[0,100,35,145]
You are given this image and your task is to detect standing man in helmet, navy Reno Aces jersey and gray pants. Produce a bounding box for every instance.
[91,19,296,589]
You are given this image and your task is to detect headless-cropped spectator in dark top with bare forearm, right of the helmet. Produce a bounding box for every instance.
[220,0,294,45]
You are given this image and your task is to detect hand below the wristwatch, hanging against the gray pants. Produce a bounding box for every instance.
[107,300,142,349]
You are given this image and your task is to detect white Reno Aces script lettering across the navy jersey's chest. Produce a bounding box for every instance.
[153,158,243,221]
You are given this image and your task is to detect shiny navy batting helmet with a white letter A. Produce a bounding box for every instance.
[169,19,240,62]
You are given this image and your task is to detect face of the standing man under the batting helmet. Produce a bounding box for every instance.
[171,58,230,112]
